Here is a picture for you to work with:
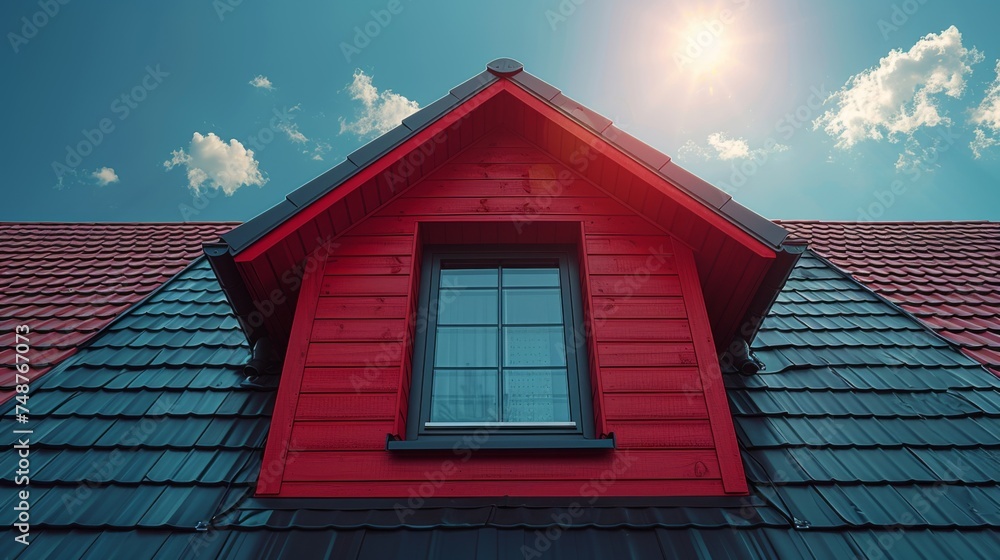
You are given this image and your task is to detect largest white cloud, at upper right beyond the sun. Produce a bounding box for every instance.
[813,26,983,149]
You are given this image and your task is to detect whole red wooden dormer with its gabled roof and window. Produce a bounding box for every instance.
[206,59,797,498]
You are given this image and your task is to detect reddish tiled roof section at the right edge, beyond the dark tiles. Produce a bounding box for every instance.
[781,221,1000,375]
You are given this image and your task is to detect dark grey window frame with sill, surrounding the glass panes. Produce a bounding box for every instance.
[387,244,614,450]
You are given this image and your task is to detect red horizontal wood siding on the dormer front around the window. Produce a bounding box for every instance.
[258,133,746,498]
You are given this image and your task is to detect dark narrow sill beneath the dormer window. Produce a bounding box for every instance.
[385,433,616,452]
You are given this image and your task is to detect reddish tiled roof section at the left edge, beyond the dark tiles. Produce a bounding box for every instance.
[0,222,236,402]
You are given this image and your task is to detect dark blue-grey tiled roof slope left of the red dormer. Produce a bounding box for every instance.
[0,258,273,558]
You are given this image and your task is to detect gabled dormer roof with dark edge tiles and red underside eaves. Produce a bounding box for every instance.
[206,59,802,358]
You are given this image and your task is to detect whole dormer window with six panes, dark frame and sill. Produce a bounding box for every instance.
[389,245,613,449]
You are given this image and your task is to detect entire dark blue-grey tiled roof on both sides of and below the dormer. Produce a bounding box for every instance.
[7,253,1000,560]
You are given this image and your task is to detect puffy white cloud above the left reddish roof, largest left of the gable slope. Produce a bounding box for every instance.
[163,132,267,196]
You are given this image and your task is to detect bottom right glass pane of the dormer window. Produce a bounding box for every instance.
[503,369,570,422]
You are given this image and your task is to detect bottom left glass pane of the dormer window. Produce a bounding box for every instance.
[430,369,499,422]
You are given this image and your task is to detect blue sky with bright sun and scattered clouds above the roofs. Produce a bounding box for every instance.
[0,0,1000,221]
